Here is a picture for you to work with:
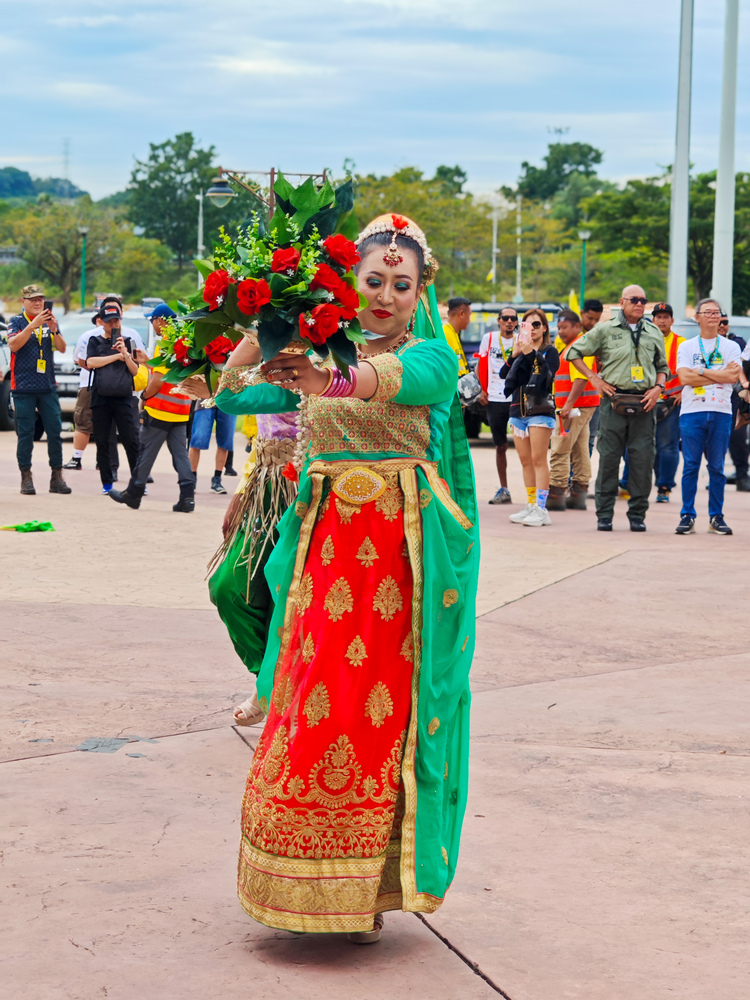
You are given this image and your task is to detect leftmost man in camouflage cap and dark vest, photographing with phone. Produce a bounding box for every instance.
[8,285,72,496]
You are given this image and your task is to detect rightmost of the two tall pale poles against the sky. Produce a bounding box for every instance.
[711,0,740,316]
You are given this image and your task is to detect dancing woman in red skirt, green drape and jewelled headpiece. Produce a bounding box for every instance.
[217,215,479,943]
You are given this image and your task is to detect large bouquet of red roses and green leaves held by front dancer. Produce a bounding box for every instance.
[184,174,366,374]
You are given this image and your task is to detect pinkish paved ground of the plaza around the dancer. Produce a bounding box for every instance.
[0,426,750,1000]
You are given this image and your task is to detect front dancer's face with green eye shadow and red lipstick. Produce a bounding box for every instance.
[357,246,422,340]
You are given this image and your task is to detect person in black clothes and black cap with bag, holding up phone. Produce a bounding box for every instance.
[86,303,138,493]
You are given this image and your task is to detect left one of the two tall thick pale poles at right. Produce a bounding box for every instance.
[667,0,694,319]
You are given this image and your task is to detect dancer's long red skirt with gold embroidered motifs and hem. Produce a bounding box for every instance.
[239,477,414,931]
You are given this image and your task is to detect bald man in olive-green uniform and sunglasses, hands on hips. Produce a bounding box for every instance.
[568,285,669,531]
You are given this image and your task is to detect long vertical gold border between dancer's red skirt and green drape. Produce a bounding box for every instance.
[399,468,426,912]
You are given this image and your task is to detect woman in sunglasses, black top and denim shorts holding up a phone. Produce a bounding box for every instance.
[500,309,560,528]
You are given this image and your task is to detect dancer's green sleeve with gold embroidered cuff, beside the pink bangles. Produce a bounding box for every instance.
[368,340,458,406]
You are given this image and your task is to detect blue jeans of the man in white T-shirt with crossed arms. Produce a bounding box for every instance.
[680,410,732,517]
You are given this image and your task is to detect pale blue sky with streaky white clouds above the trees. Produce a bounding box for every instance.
[0,0,750,198]
